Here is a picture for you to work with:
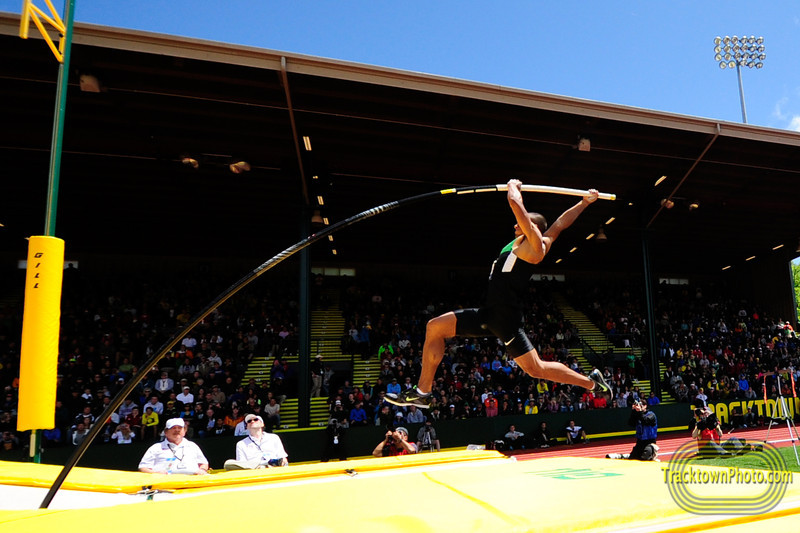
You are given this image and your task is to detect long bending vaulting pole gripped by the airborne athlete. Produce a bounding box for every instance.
[39,184,616,509]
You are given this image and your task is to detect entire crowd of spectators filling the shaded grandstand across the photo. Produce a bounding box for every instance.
[0,260,800,449]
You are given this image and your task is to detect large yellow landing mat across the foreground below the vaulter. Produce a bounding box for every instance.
[0,452,800,533]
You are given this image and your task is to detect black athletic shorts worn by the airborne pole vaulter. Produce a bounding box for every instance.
[454,307,533,359]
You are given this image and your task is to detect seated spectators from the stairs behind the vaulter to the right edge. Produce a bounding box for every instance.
[331,274,800,432]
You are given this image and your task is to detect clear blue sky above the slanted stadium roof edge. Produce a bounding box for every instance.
[0,0,800,131]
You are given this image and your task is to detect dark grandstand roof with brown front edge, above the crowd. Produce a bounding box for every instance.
[0,14,800,275]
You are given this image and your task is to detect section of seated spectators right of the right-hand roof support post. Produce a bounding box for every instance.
[656,280,800,406]
